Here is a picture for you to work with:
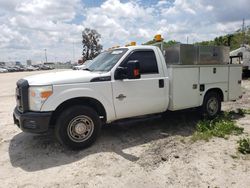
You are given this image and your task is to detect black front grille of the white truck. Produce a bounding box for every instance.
[16,79,29,112]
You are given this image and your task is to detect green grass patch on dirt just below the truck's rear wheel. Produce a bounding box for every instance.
[191,112,244,141]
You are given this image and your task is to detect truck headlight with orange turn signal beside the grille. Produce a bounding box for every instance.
[29,86,53,111]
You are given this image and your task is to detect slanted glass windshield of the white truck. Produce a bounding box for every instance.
[88,48,128,71]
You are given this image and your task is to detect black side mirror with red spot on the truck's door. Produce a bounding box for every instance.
[127,60,141,79]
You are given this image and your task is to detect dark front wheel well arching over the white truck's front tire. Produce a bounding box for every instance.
[50,97,107,128]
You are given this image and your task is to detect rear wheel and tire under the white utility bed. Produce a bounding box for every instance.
[201,91,221,119]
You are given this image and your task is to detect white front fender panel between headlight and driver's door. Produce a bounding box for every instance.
[41,82,115,121]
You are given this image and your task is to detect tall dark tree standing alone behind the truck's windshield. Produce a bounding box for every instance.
[82,28,102,61]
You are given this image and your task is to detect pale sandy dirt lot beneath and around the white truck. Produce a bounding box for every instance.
[0,72,250,188]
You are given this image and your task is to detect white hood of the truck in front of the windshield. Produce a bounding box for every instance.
[24,70,110,86]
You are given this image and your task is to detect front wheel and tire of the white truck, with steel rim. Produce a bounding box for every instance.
[55,105,101,150]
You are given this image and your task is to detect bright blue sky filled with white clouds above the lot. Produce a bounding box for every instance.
[0,0,250,62]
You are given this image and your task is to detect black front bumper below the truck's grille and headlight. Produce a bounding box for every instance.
[13,108,52,133]
